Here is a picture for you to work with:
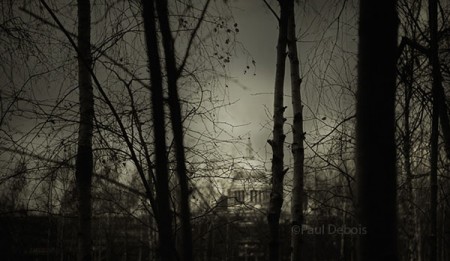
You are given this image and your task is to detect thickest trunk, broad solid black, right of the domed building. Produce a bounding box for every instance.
[356,0,398,261]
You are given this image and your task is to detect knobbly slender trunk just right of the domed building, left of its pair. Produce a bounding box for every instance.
[267,0,288,261]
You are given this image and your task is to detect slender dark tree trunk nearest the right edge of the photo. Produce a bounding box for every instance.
[428,0,444,261]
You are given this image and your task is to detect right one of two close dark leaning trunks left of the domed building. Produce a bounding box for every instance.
[156,0,193,261]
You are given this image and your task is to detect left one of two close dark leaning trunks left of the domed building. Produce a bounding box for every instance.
[142,0,176,261]
